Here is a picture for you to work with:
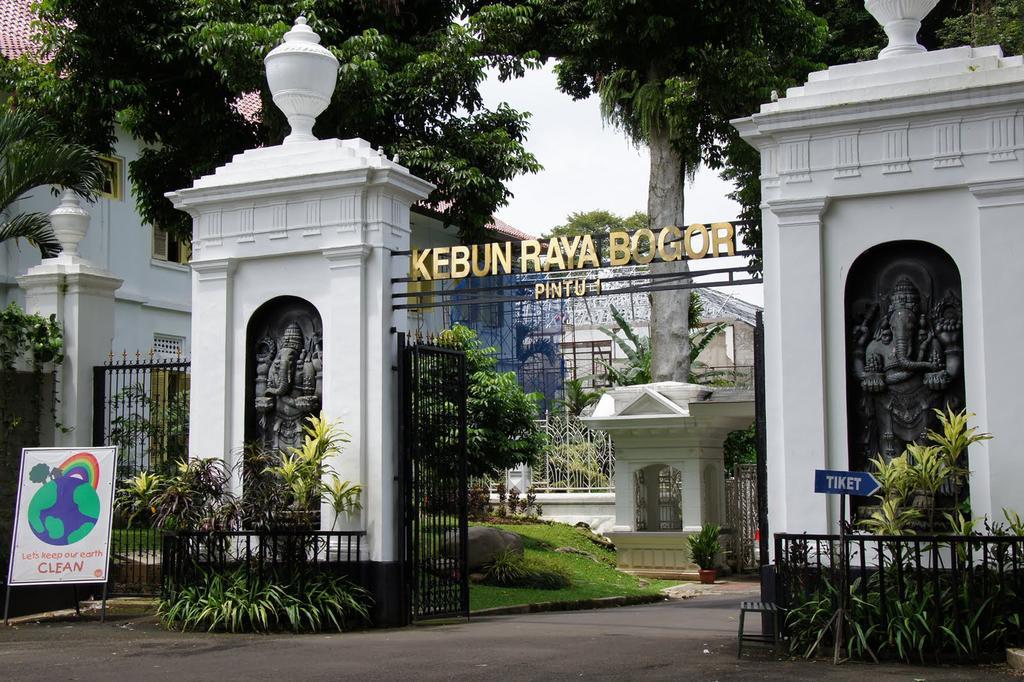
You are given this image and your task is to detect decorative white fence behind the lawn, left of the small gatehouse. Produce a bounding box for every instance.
[530,415,615,493]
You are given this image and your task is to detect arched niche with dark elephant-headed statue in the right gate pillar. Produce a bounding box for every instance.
[845,241,965,470]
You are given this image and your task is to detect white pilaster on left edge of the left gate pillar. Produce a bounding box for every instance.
[188,258,234,475]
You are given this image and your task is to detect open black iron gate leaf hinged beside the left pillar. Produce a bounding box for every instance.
[398,334,469,621]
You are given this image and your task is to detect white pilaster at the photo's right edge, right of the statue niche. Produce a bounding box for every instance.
[964,179,1024,520]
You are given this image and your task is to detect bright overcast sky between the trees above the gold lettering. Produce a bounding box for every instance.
[480,65,763,305]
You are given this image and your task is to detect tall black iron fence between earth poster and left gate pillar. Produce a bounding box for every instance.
[92,353,189,595]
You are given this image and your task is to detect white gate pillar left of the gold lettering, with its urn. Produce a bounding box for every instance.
[168,15,433,624]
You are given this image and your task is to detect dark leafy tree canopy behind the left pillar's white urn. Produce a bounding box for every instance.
[0,0,540,240]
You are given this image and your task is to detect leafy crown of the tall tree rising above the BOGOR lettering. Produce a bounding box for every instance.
[473,0,825,254]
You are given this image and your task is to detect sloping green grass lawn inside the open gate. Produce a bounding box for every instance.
[469,523,678,611]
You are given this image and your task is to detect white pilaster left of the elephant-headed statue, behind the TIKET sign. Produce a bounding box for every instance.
[765,198,831,534]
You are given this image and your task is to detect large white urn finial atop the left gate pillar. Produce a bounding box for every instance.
[263,16,338,144]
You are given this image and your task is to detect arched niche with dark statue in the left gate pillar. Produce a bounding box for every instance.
[246,296,324,450]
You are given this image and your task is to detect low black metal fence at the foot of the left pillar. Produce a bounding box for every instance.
[161,530,367,596]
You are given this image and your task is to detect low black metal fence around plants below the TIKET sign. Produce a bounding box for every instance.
[775,534,1024,659]
